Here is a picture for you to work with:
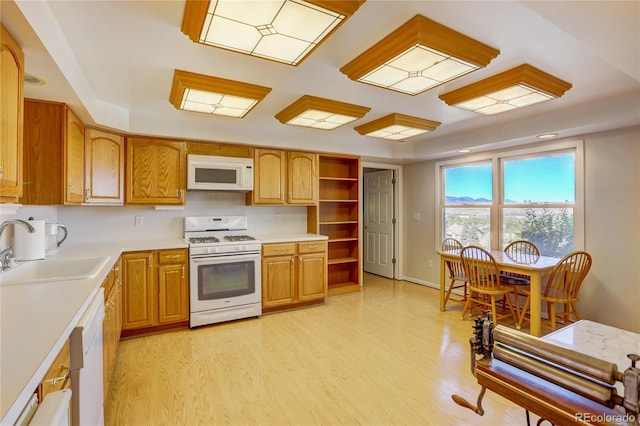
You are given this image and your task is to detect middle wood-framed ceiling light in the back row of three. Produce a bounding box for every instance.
[275,95,371,130]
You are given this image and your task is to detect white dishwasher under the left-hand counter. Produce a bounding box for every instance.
[70,287,104,426]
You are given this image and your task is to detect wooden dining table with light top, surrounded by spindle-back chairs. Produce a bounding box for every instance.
[436,250,560,337]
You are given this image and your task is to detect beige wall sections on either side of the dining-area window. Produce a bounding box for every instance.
[402,127,640,333]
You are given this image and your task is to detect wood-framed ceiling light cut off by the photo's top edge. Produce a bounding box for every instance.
[182,0,365,65]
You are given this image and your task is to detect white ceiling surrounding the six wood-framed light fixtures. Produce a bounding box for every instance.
[0,0,640,163]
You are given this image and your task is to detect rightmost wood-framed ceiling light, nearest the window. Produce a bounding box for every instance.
[440,64,571,115]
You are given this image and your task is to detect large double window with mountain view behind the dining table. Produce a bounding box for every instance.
[436,141,584,257]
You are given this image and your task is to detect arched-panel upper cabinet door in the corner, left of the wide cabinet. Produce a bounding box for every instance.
[84,128,124,205]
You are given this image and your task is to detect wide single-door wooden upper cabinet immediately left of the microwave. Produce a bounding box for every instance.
[125,137,187,205]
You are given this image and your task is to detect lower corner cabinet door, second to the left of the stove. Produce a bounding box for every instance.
[122,252,157,330]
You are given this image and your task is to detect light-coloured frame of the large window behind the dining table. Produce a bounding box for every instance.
[434,139,585,250]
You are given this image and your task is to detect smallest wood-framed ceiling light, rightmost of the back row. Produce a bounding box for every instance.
[354,113,440,141]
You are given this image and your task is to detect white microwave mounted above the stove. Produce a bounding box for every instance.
[187,154,253,192]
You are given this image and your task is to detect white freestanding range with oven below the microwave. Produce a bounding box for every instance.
[184,216,262,327]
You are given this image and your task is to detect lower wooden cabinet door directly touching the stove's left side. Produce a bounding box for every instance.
[158,263,189,324]
